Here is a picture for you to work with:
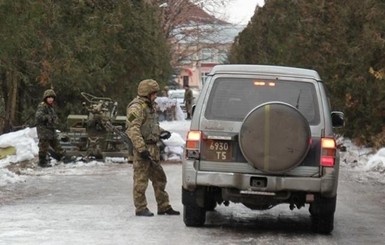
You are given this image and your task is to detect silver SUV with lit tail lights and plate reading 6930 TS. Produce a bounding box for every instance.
[182,65,344,233]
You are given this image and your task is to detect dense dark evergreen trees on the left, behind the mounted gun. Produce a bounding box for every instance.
[0,0,171,131]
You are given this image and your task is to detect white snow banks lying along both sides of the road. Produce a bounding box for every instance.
[0,120,385,186]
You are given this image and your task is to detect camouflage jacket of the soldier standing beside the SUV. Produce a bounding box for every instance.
[126,96,163,161]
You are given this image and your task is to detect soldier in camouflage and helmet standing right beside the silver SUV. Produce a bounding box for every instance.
[126,79,180,216]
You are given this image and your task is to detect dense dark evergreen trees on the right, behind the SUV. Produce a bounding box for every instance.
[229,0,385,146]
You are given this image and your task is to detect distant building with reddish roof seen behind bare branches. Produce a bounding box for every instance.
[162,0,244,89]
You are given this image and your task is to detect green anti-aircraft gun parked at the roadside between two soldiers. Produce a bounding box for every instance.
[59,92,132,159]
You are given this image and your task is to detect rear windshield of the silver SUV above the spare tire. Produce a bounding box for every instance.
[205,78,320,125]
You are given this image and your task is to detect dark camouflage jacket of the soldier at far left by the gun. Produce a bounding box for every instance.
[35,102,58,139]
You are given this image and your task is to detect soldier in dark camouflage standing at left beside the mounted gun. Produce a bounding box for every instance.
[35,89,64,167]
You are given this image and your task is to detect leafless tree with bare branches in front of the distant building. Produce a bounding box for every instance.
[148,0,234,68]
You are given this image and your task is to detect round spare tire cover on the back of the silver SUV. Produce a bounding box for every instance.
[239,102,311,173]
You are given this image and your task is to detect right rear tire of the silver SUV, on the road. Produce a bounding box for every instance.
[309,197,337,234]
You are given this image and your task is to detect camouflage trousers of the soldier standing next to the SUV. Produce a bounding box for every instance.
[133,159,171,212]
